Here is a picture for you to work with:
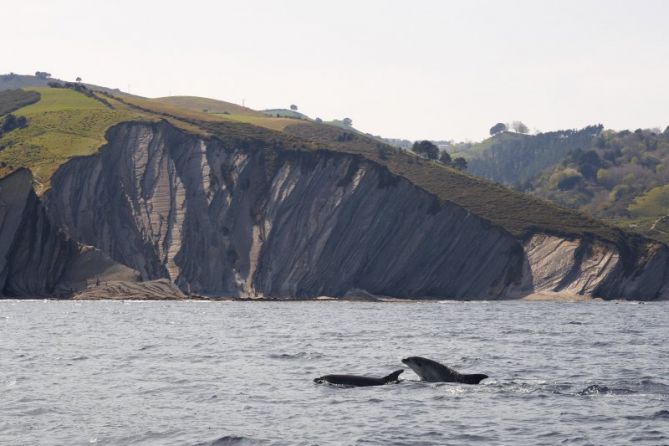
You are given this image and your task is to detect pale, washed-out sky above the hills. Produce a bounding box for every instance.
[5,0,669,141]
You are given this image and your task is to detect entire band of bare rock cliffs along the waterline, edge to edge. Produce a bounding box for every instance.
[0,122,669,299]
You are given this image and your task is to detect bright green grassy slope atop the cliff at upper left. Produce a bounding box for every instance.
[0,87,306,190]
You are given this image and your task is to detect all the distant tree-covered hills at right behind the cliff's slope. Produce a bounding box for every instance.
[452,125,669,242]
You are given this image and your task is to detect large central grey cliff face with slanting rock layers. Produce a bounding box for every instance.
[46,123,523,298]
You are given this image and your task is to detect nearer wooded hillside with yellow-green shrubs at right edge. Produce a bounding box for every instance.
[526,129,669,242]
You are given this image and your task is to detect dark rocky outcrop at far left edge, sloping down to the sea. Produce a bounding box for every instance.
[0,169,138,297]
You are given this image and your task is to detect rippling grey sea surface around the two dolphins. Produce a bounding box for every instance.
[0,300,669,446]
